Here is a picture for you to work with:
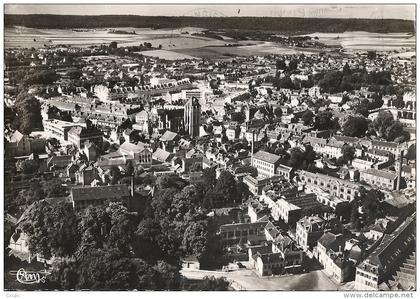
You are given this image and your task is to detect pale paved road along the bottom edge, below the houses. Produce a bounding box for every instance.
[181,269,339,291]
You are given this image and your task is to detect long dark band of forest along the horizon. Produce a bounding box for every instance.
[4,11,415,34]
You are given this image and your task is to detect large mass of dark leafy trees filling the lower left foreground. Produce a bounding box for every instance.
[11,170,238,290]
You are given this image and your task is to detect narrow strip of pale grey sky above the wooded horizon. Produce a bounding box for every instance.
[4,4,416,20]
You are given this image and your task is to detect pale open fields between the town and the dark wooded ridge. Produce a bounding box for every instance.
[5,26,416,60]
